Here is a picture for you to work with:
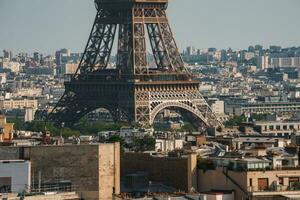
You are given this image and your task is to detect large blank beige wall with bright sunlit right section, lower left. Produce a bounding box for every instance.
[0,143,120,200]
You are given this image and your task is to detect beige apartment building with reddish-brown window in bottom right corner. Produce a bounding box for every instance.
[198,164,300,200]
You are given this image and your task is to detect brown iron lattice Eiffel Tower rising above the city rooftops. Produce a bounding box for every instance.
[48,0,222,127]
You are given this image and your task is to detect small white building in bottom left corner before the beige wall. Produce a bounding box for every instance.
[0,160,31,193]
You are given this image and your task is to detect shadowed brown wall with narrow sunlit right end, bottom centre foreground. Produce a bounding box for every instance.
[121,153,197,192]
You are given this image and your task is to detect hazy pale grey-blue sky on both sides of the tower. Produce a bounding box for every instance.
[0,0,300,55]
